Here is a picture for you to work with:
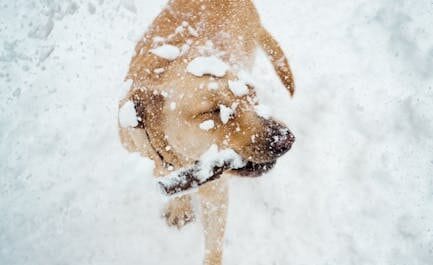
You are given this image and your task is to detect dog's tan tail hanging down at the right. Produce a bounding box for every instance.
[257,27,295,96]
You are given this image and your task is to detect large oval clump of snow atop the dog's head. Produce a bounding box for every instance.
[187,56,229,77]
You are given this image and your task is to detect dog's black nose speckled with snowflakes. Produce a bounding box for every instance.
[265,120,295,158]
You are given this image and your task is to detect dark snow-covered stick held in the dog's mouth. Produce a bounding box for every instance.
[158,145,276,195]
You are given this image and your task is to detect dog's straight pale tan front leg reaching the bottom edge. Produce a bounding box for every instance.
[199,177,228,265]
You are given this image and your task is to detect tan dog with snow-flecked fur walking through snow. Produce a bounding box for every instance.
[119,0,295,265]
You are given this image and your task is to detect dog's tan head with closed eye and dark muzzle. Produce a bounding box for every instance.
[121,68,295,176]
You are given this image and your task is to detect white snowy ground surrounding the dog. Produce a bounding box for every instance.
[0,0,433,265]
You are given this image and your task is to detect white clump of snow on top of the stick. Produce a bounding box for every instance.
[197,144,246,182]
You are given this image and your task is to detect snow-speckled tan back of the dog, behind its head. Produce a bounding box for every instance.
[128,0,261,82]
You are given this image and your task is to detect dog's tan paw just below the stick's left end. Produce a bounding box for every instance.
[163,196,195,229]
